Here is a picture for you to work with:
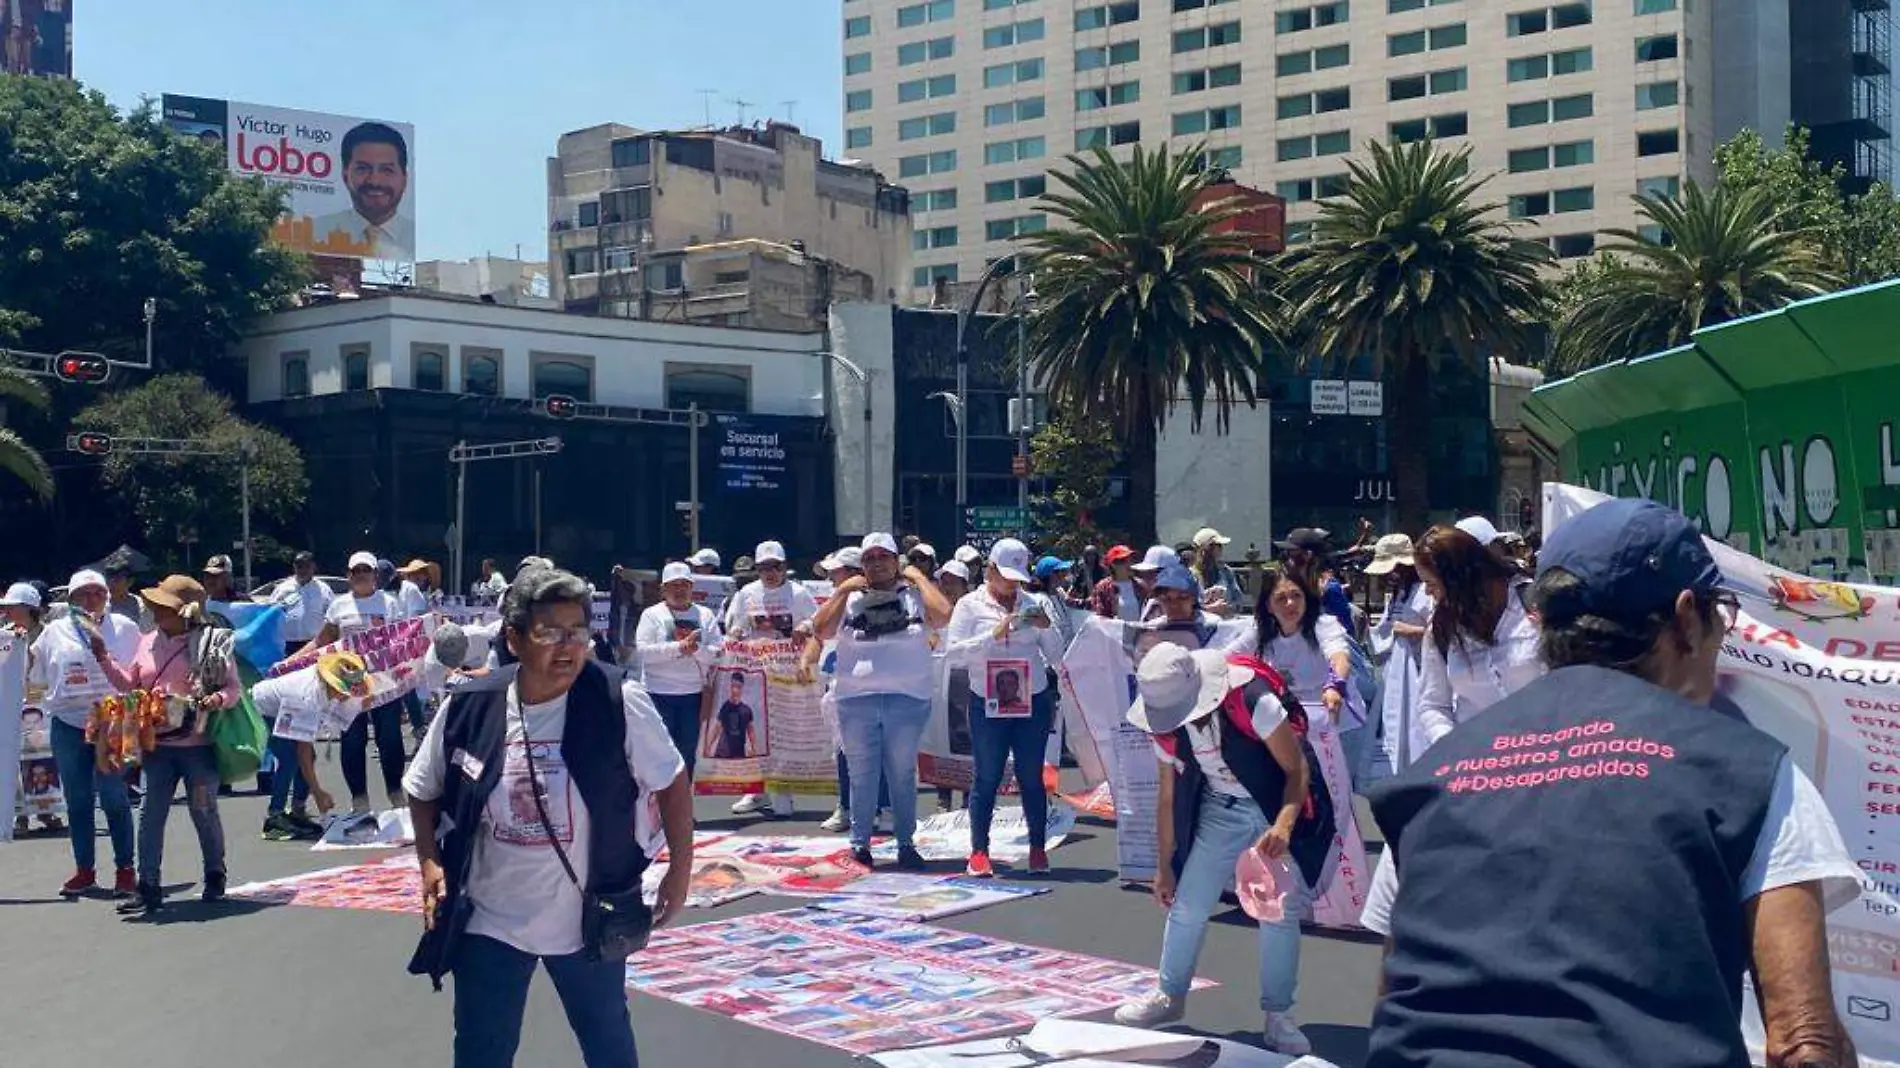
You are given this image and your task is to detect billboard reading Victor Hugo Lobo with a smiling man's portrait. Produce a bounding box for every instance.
[163,94,416,262]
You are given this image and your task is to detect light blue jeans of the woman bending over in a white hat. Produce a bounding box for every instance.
[1161,791,1307,1013]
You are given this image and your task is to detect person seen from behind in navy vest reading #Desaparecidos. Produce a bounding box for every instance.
[1364,500,1858,1068]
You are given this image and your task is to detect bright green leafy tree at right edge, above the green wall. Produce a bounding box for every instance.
[1716,125,1900,285]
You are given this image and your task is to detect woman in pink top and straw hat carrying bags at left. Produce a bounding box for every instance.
[93,574,239,914]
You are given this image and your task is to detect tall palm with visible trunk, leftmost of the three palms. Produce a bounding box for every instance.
[1020,144,1275,542]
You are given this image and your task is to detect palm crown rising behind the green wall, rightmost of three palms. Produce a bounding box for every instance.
[1552,181,1841,372]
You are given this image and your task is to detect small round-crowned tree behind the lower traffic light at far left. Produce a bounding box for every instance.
[74,374,310,563]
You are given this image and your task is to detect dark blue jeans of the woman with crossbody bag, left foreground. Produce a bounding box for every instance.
[454,935,640,1068]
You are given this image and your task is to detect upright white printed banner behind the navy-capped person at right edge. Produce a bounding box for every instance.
[1543,483,1900,1062]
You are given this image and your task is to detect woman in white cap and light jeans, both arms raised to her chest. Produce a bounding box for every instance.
[811,532,950,870]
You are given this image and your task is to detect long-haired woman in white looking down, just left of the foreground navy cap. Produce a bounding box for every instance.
[1408,526,1545,760]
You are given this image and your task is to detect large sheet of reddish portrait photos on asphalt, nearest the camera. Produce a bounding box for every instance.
[627,908,1212,1053]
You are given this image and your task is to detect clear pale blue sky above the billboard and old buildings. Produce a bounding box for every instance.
[72,0,842,258]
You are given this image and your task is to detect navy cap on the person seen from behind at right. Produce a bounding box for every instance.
[1537,498,1721,623]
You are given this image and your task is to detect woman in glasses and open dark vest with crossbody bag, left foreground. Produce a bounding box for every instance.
[403,568,694,1068]
